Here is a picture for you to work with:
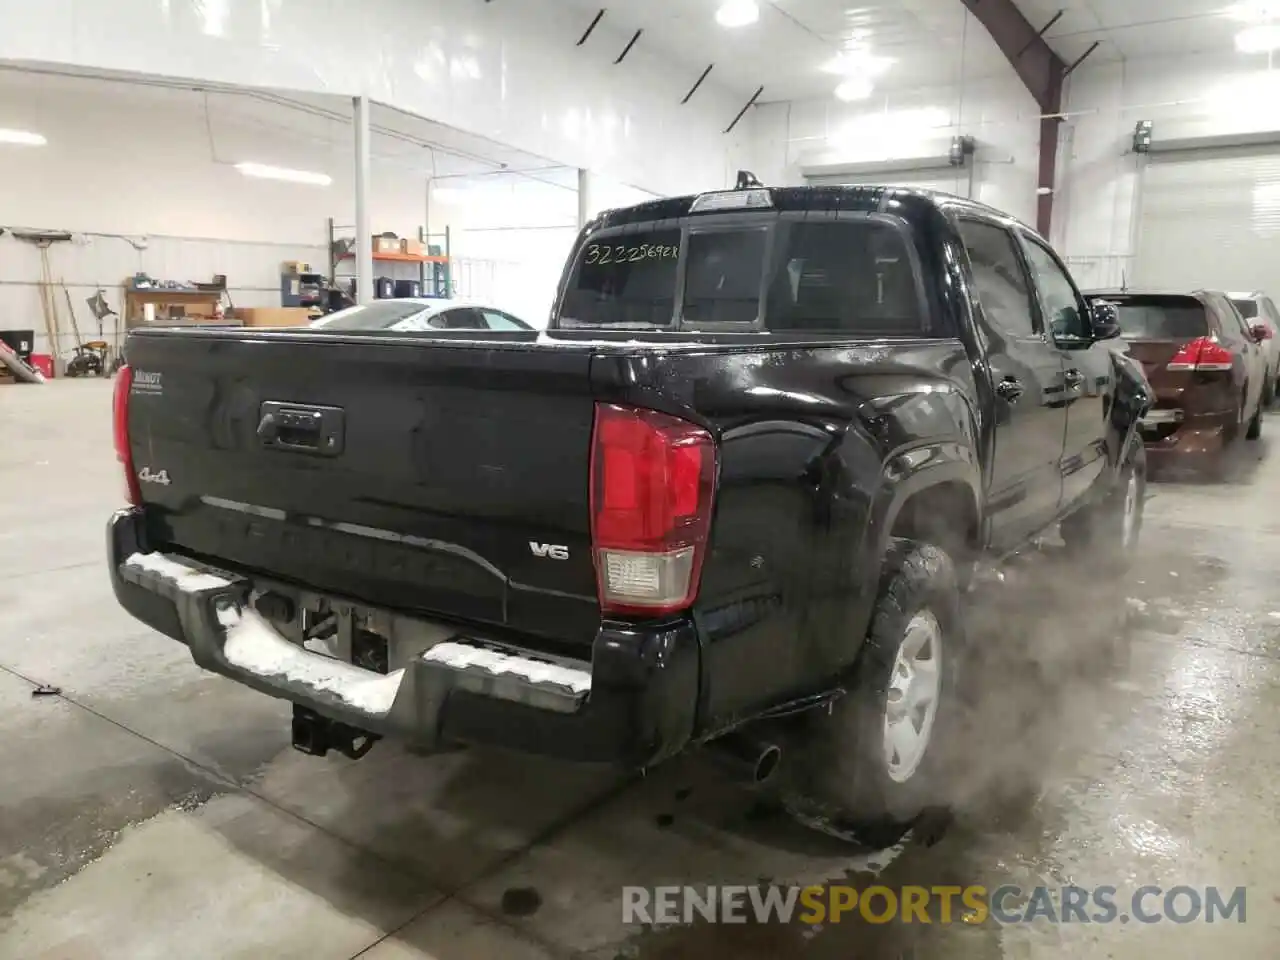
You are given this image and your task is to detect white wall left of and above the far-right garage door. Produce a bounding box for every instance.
[1053,55,1280,287]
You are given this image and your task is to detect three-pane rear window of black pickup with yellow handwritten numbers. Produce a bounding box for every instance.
[559,215,927,337]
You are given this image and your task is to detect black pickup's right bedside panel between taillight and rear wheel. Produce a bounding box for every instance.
[593,339,980,732]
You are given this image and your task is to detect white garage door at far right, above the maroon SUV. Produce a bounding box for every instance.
[1133,147,1280,294]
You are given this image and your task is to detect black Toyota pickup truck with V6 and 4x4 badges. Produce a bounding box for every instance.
[108,187,1149,828]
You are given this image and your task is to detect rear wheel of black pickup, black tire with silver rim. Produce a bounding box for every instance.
[785,539,964,847]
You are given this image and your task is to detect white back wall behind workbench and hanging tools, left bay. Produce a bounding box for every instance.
[0,72,445,352]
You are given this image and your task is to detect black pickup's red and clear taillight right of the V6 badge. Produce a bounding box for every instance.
[591,403,716,614]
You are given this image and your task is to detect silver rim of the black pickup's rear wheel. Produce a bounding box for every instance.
[884,611,942,783]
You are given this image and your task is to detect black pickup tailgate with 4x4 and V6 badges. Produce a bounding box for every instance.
[128,332,599,644]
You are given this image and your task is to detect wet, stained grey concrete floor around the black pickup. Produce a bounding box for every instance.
[0,381,1280,960]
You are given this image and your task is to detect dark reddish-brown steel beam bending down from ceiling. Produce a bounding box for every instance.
[961,0,1070,237]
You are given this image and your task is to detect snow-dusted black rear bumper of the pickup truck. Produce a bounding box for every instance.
[108,509,700,768]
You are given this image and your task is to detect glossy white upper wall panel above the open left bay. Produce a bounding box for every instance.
[0,0,745,193]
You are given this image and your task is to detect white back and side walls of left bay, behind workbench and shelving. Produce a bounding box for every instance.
[0,70,670,353]
